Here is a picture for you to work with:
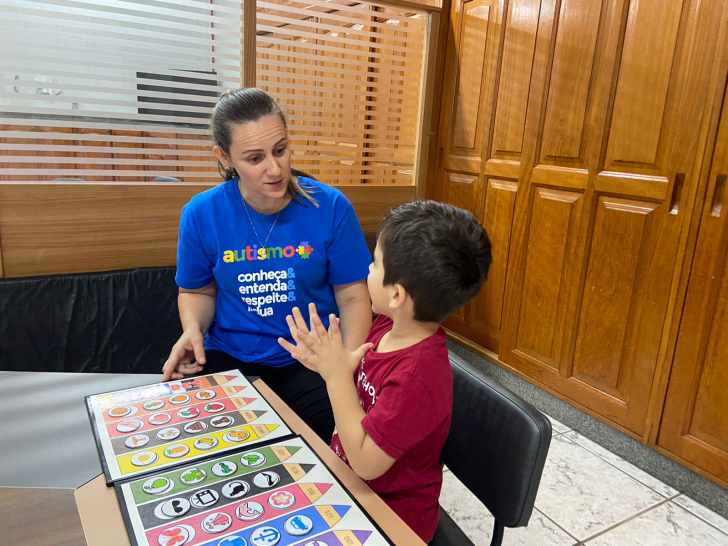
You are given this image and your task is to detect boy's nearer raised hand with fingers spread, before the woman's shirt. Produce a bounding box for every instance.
[278,304,373,383]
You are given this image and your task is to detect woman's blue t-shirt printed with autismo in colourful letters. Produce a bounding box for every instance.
[175,177,371,367]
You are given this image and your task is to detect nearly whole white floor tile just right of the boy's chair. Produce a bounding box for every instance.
[536,436,665,540]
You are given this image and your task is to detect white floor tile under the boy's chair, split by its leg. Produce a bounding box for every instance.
[440,472,576,546]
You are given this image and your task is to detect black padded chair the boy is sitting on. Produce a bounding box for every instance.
[430,353,551,546]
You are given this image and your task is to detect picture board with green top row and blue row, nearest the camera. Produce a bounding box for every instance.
[116,437,391,546]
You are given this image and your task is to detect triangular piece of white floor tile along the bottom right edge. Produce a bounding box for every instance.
[585,502,728,546]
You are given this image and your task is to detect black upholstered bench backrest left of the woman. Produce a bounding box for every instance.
[0,267,182,373]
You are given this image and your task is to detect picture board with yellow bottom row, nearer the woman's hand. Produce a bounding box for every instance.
[86,370,292,485]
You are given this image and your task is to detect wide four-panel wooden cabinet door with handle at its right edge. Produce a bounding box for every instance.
[496,0,721,434]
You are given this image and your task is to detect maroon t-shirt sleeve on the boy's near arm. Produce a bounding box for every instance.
[361,373,444,459]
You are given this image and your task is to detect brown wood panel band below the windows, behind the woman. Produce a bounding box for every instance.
[0,182,415,277]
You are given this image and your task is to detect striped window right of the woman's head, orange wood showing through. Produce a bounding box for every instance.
[256,0,427,185]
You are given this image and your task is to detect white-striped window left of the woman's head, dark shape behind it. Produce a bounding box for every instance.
[0,0,242,181]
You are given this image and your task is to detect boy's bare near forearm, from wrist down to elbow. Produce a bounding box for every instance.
[326,374,396,480]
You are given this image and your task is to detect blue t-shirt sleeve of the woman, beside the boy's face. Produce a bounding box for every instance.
[326,195,372,285]
